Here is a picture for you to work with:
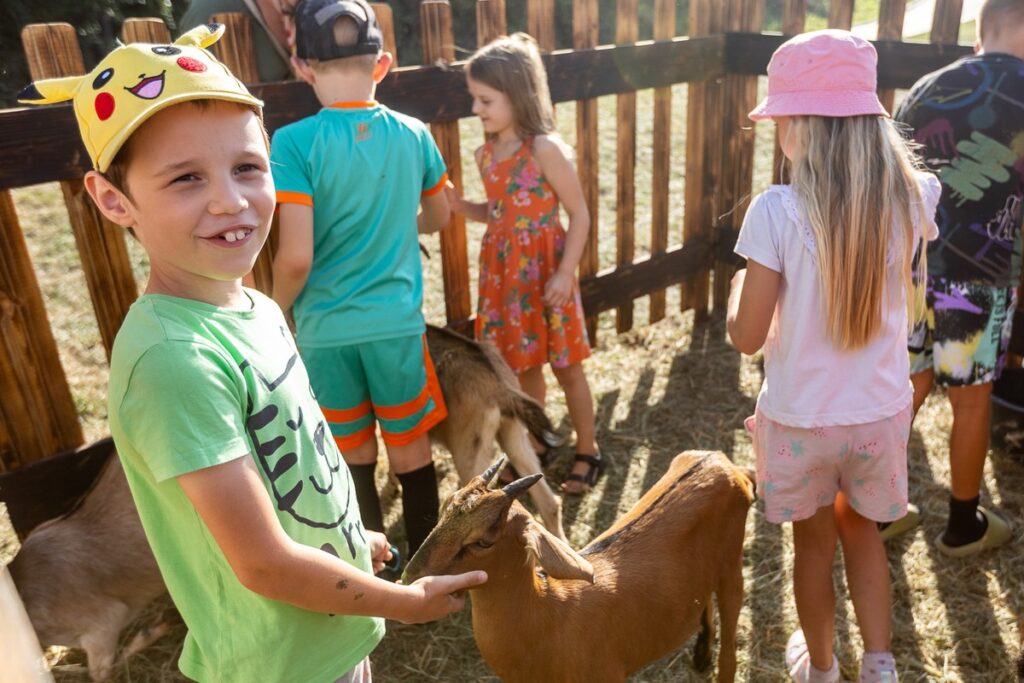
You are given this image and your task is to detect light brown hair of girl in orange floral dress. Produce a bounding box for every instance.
[466,33,555,137]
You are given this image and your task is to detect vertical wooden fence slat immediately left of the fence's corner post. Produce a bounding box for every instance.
[680,0,725,323]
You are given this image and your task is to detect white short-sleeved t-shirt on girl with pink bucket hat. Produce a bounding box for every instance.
[735,173,942,427]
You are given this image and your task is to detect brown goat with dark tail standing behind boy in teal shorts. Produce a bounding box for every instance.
[427,325,565,540]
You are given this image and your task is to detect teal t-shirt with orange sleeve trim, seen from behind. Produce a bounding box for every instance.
[270,102,447,348]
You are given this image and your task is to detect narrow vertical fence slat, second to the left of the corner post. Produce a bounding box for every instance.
[649,0,676,323]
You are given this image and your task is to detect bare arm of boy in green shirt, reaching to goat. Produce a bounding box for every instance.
[177,457,486,624]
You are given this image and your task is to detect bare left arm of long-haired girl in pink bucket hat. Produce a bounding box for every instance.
[726,260,782,354]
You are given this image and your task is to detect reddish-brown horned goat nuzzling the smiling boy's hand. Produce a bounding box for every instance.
[403,451,754,683]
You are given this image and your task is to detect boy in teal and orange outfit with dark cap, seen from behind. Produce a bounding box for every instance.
[270,0,450,556]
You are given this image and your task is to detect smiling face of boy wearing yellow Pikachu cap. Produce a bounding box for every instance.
[89,100,274,305]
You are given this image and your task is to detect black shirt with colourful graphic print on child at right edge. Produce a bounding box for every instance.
[896,52,1024,287]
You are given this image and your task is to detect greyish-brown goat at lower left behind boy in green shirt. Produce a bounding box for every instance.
[10,456,167,681]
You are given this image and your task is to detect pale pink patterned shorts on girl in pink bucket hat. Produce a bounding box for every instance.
[744,405,913,524]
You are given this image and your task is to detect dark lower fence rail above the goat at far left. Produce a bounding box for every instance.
[0,438,114,539]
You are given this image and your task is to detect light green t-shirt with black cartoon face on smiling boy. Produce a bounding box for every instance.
[109,290,384,683]
